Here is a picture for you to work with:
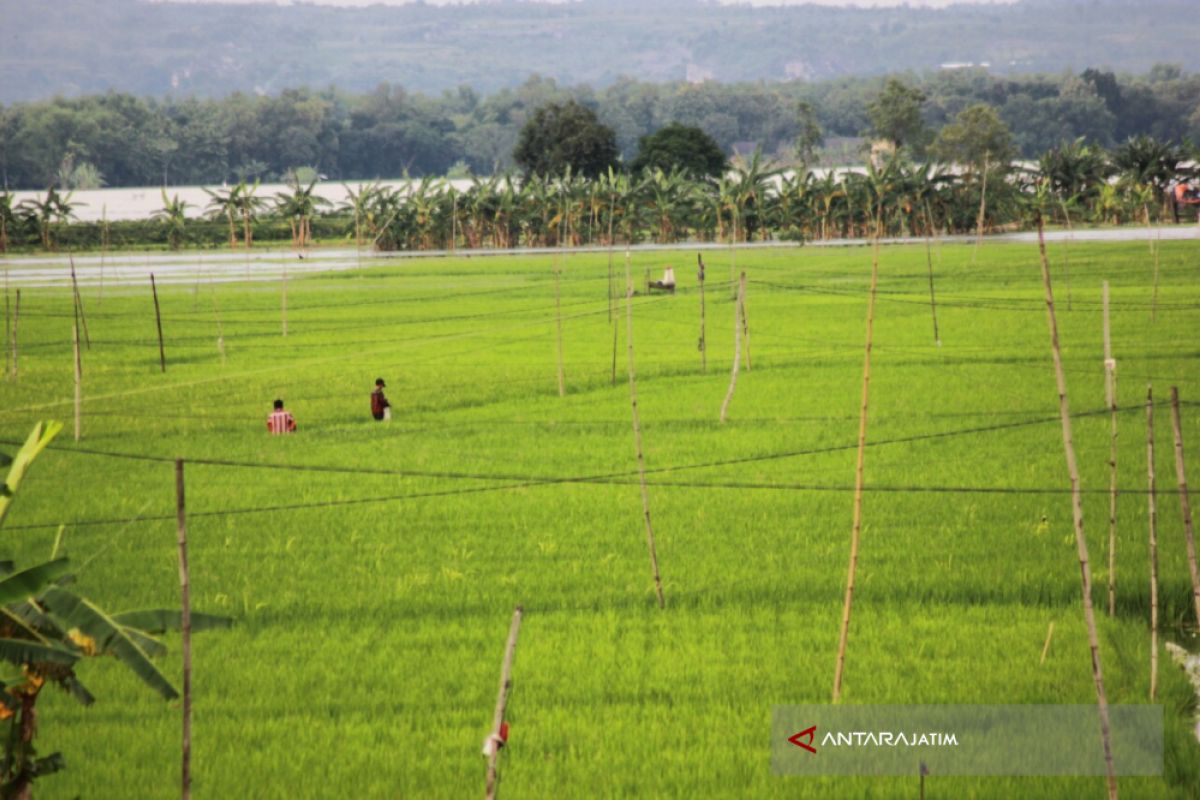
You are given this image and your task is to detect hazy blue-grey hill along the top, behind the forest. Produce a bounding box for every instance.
[0,0,1200,103]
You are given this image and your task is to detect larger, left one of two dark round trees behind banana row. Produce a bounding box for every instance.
[512,100,618,178]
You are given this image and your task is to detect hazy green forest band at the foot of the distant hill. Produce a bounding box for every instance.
[0,66,1200,190]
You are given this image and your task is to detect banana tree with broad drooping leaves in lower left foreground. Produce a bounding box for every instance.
[0,422,230,800]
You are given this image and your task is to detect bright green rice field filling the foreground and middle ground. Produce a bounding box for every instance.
[0,241,1200,800]
